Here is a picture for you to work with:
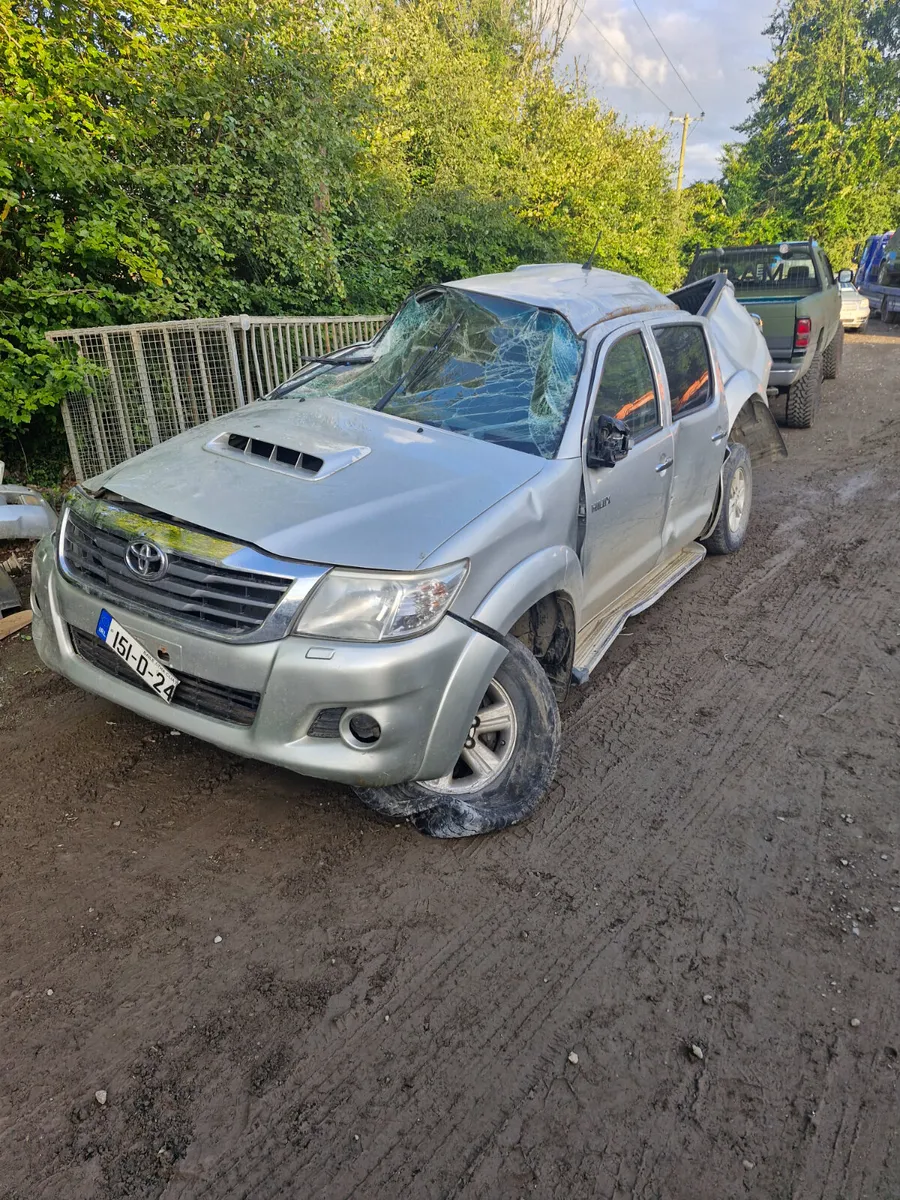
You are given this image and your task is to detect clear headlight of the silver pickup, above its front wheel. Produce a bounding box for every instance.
[294,562,469,642]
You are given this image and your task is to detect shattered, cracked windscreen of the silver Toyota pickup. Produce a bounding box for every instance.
[290,288,583,458]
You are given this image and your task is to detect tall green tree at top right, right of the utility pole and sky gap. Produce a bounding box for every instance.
[725,0,900,265]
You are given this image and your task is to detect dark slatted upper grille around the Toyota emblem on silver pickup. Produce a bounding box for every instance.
[62,509,292,637]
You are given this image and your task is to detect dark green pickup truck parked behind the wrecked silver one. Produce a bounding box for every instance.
[685,240,850,430]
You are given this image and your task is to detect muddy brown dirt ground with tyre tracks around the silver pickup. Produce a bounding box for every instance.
[0,323,900,1200]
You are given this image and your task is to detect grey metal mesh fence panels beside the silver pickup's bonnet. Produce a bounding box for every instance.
[47,316,388,480]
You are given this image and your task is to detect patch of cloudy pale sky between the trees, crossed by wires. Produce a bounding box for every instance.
[563,0,775,184]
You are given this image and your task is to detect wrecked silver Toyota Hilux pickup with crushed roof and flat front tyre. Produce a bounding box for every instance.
[32,265,785,838]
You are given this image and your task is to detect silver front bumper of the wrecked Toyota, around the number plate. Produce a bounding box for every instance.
[32,538,506,787]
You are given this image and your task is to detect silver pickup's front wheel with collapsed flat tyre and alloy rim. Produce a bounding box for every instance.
[355,637,562,838]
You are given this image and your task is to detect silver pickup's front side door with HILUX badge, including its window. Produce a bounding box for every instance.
[581,330,674,624]
